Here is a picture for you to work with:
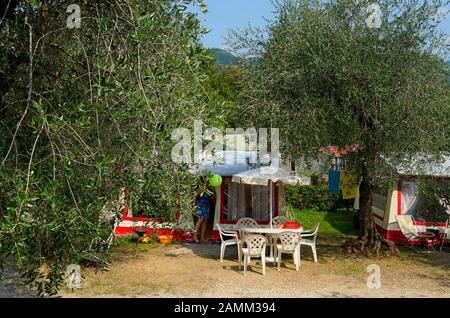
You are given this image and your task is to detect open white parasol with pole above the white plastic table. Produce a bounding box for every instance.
[232,166,311,226]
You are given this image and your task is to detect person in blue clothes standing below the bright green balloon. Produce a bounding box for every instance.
[194,188,213,243]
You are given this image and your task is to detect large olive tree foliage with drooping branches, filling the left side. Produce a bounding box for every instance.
[0,0,222,294]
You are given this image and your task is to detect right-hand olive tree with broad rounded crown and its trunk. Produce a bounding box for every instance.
[229,0,450,243]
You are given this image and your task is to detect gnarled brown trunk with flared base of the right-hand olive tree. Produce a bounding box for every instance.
[344,158,398,256]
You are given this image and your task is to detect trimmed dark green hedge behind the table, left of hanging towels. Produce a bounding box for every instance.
[285,185,338,211]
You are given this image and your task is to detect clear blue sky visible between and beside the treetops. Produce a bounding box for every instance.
[193,0,450,48]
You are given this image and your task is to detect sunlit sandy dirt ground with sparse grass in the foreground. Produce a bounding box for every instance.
[56,237,450,298]
